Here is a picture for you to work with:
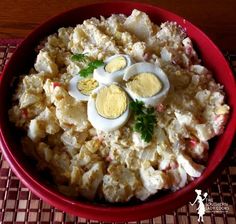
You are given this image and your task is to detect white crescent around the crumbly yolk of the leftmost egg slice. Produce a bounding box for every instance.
[68,75,98,101]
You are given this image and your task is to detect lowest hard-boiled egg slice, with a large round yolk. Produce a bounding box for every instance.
[87,84,129,132]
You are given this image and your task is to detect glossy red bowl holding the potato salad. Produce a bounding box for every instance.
[0,2,236,221]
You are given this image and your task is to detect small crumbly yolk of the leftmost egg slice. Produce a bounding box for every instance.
[77,78,98,96]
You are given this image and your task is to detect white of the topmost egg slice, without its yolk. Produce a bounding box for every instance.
[93,54,132,85]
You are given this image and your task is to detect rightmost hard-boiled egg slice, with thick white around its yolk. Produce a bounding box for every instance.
[123,62,170,106]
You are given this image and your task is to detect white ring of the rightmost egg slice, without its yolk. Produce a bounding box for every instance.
[123,62,170,106]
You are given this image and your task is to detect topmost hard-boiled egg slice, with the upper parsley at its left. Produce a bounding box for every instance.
[93,54,132,85]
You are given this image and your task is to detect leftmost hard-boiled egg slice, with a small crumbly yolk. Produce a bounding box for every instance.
[68,75,99,101]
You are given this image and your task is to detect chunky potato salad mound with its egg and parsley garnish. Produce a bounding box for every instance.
[9,9,230,203]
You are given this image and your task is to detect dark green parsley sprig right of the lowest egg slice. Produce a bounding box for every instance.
[130,100,156,142]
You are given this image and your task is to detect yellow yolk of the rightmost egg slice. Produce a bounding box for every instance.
[126,72,162,98]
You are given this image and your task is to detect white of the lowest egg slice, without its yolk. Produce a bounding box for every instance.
[87,86,130,132]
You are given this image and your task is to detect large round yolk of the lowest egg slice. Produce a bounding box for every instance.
[96,84,128,119]
